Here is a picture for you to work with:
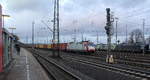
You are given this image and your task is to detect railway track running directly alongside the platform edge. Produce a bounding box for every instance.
[32,51,81,80]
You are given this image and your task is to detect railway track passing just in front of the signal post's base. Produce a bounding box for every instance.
[63,55,150,80]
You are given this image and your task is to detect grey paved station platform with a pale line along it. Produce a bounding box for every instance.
[0,48,50,80]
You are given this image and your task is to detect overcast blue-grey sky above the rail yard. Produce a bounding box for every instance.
[0,0,150,43]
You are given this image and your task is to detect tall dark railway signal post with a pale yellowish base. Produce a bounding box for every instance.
[105,8,114,63]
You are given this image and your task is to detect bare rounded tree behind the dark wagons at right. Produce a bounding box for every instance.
[129,29,143,43]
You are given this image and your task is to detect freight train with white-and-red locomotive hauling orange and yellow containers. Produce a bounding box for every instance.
[28,41,96,53]
